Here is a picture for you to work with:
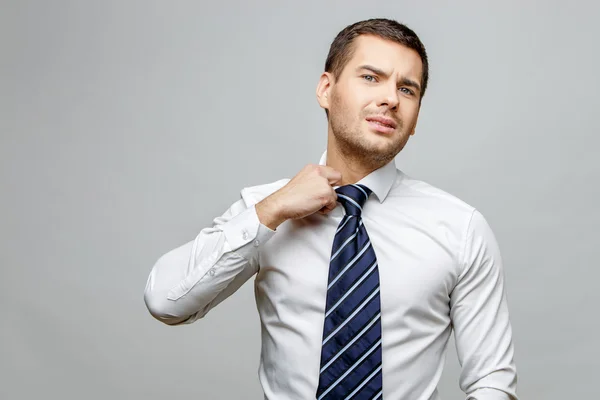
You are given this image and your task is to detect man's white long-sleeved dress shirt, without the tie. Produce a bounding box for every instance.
[144,152,517,400]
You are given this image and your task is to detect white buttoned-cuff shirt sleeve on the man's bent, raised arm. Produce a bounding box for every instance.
[144,198,275,325]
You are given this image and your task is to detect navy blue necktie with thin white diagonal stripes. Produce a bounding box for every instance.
[317,184,382,400]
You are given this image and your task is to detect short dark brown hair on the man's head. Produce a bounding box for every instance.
[325,18,429,99]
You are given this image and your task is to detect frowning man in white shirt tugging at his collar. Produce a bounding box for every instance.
[145,19,517,400]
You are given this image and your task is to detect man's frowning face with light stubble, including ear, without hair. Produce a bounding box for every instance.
[317,35,423,166]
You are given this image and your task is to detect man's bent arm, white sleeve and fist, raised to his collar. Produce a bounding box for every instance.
[144,164,342,325]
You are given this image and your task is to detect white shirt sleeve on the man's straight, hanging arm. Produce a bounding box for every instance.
[450,210,517,400]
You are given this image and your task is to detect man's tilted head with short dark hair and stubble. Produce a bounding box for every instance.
[317,19,429,167]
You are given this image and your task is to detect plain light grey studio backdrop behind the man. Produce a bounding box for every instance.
[0,0,600,400]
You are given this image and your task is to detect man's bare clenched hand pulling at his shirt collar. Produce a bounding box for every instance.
[256,164,342,230]
